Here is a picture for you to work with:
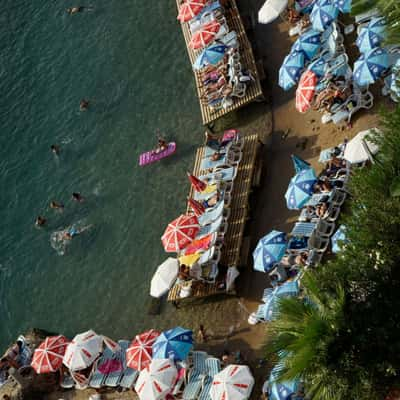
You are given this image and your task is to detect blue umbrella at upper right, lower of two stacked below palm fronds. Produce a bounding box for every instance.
[353,47,390,86]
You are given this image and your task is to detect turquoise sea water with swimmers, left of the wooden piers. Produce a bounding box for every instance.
[0,0,202,348]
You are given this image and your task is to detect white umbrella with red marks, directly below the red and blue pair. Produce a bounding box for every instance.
[135,359,178,400]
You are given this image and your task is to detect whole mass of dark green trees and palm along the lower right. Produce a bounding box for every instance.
[268,107,400,400]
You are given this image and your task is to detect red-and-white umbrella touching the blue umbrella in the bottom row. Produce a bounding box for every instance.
[126,329,160,371]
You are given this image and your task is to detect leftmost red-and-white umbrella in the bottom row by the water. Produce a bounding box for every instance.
[31,335,69,374]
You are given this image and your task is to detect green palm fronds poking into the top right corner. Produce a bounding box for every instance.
[352,0,400,44]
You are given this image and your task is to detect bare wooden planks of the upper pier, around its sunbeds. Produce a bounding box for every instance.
[176,0,263,125]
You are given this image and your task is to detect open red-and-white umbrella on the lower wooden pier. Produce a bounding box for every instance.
[161,215,200,253]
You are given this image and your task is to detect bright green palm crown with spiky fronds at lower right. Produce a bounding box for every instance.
[267,272,346,400]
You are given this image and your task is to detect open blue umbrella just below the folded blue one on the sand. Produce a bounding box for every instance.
[285,168,317,210]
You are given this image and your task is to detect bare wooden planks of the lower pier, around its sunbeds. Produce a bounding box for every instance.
[168,134,260,301]
